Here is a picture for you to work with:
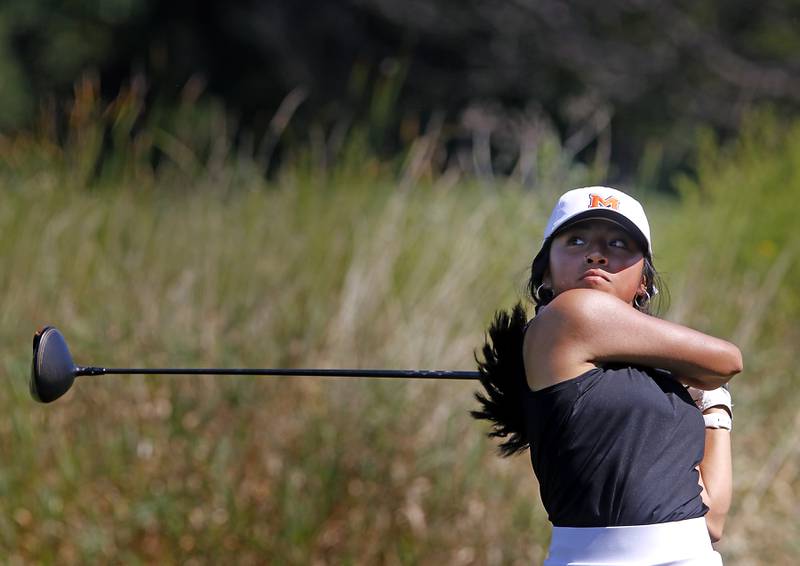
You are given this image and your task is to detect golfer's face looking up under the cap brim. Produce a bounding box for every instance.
[544,219,645,304]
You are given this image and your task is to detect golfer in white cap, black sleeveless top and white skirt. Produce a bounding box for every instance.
[473,187,742,566]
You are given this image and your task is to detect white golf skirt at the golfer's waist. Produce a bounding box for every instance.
[544,517,722,566]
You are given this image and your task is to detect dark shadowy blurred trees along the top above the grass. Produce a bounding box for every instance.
[0,0,800,182]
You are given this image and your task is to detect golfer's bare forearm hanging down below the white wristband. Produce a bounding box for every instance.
[700,407,733,542]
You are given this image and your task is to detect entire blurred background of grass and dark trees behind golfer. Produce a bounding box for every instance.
[0,0,800,565]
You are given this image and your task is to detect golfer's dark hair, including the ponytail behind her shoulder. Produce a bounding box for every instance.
[470,242,665,457]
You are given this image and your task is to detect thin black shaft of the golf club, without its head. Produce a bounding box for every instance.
[75,366,480,379]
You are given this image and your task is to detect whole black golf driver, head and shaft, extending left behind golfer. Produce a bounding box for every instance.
[30,326,480,403]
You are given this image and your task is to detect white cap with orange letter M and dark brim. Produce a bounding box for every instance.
[539,186,653,256]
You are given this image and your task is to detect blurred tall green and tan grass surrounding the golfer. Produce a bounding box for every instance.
[0,89,800,564]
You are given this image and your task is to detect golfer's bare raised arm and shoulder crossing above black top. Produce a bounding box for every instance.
[525,289,742,389]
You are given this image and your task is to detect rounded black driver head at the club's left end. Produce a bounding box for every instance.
[30,326,76,403]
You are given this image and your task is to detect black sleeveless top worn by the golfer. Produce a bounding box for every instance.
[525,366,708,527]
